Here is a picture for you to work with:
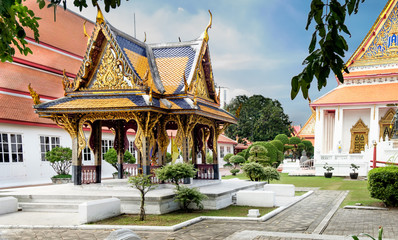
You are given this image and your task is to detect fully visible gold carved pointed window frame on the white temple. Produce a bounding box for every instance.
[350,119,369,153]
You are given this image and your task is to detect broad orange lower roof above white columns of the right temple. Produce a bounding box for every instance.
[311,83,398,106]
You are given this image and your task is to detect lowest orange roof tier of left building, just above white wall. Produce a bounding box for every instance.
[0,94,55,125]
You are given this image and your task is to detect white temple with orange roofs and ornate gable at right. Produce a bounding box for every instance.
[310,0,398,176]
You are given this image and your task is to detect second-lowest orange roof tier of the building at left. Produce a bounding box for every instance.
[0,63,64,98]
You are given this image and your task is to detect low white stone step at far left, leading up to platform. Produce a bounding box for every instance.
[18,202,79,213]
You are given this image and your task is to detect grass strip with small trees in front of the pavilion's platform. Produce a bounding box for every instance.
[95,206,275,226]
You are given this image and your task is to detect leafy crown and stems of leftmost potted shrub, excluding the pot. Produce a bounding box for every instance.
[46,147,72,175]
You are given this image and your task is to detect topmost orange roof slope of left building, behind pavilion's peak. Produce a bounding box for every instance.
[24,0,95,56]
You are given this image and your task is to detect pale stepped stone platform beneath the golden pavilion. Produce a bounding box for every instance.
[0,179,265,214]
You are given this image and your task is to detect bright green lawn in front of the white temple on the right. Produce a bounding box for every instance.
[223,173,381,207]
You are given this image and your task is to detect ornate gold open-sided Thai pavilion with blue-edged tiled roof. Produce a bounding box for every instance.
[31,7,236,185]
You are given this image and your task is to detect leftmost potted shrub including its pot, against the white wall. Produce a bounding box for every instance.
[46,147,72,184]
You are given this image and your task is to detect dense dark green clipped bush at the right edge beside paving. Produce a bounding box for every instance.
[368,166,398,207]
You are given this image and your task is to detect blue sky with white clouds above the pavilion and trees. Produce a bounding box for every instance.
[68,0,387,126]
